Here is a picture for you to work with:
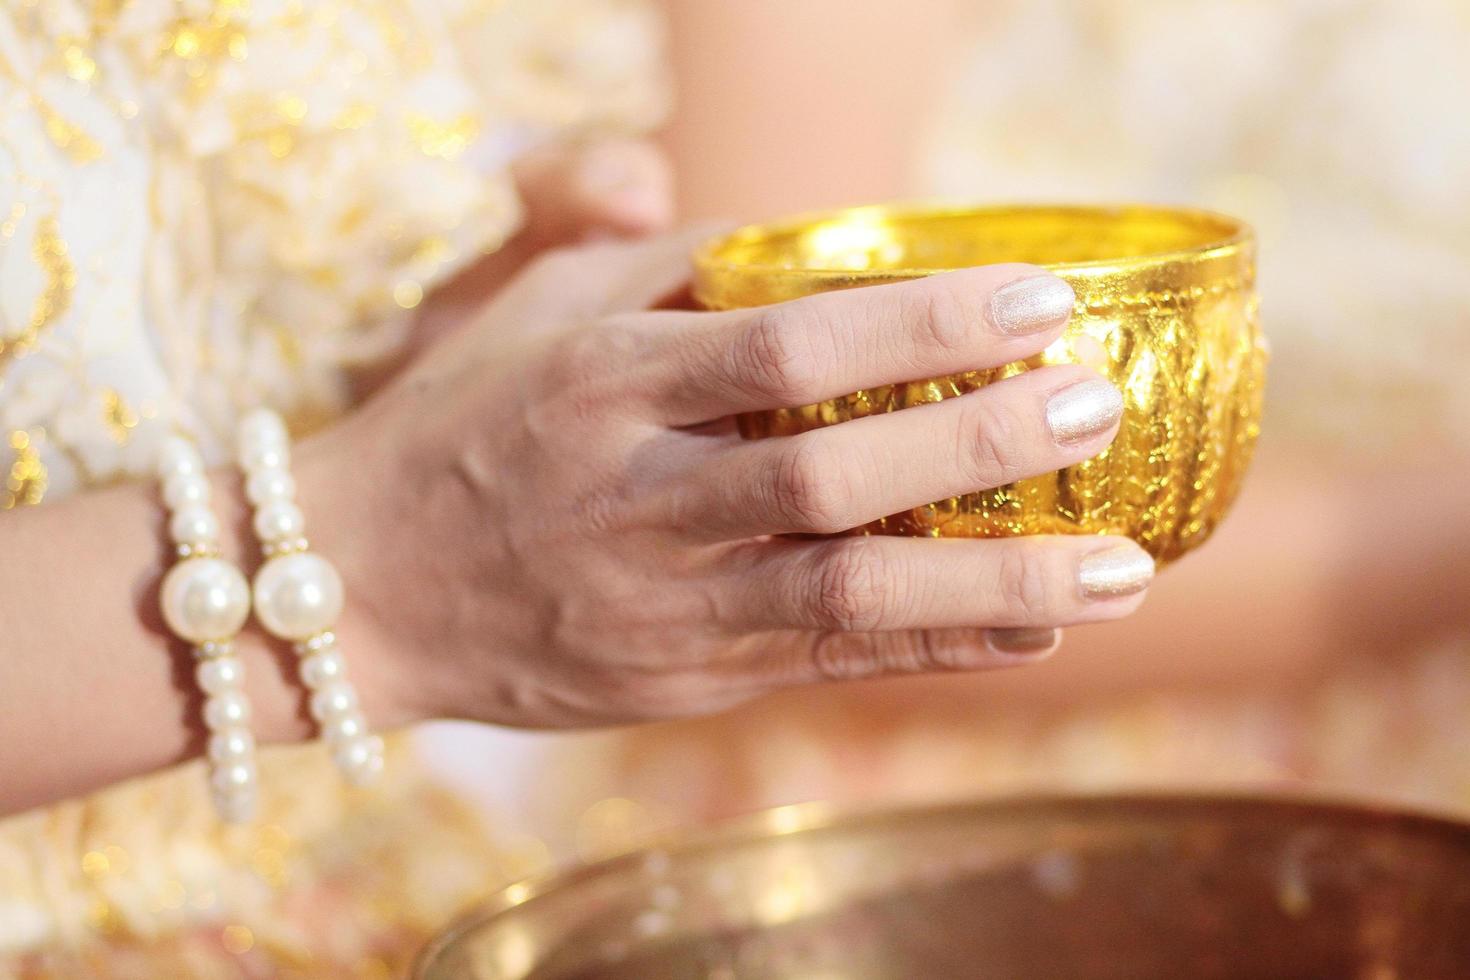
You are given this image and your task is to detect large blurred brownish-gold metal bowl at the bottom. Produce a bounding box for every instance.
[415,795,1470,980]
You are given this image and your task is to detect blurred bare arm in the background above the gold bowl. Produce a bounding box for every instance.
[667,0,964,219]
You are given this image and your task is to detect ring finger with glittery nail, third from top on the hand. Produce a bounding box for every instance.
[720,535,1154,633]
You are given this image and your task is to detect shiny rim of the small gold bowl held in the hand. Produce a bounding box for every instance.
[692,203,1255,309]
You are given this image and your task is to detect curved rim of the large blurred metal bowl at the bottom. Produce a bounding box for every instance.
[410,788,1470,979]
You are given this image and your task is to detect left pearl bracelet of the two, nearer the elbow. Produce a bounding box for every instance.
[159,436,257,823]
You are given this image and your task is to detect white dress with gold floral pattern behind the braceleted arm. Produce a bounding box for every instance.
[0,0,666,977]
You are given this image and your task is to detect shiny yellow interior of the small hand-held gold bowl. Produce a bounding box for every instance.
[701,206,1244,276]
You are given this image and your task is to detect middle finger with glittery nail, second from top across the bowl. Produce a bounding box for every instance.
[669,364,1123,541]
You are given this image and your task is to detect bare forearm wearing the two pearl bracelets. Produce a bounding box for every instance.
[0,455,391,813]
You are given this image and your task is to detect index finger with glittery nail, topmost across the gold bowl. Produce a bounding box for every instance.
[657,264,1075,425]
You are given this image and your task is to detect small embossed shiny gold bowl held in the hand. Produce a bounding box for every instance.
[694,206,1266,563]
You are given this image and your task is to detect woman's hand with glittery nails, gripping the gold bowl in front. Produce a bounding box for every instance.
[307,235,1152,727]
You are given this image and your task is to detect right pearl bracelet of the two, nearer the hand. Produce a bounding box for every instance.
[238,408,384,785]
